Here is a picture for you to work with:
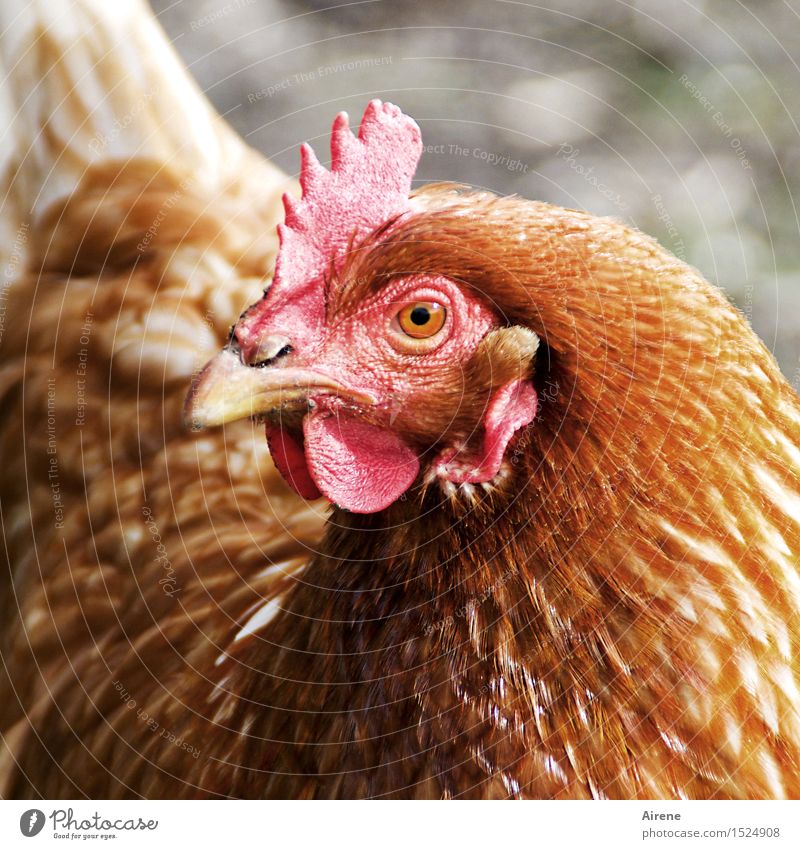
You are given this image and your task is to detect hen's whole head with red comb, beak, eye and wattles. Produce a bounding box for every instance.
[186,101,539,513]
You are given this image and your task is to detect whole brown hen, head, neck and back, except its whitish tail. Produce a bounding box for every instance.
[0,0,800,799]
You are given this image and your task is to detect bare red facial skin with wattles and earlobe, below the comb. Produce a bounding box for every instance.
[242,276,536,513]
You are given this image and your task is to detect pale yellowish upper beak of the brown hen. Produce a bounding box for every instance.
[183,348,375,430]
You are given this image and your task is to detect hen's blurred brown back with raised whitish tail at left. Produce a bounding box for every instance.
[0,0,322,797]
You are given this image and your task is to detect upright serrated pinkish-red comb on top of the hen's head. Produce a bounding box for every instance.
[236,100,422,349]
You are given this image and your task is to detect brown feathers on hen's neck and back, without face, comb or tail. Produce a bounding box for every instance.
[6,177,800,798]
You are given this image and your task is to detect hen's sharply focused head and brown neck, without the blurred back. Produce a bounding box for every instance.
[186,107,800,798]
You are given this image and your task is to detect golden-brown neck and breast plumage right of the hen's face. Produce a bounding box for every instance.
[220,195,800,798]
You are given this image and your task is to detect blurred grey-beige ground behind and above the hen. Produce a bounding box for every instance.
[153,0,800,388]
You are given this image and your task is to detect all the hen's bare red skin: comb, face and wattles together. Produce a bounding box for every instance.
[225,101,536,513]
